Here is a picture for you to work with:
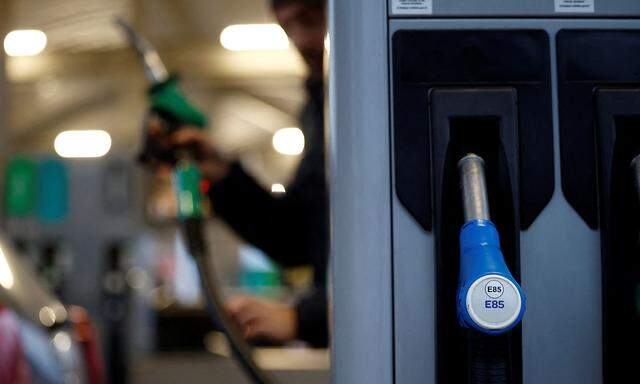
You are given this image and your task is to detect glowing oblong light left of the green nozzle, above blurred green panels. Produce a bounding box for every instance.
[53,130,111,158]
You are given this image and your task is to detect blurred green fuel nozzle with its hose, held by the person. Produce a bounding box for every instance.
[117,20,272,384]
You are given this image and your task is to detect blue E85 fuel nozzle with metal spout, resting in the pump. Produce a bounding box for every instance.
[457,154,525,334]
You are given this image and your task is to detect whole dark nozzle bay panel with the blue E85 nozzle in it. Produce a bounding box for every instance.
[393,30,554,384]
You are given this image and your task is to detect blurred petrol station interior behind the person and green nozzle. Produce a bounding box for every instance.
[0,0,329,383]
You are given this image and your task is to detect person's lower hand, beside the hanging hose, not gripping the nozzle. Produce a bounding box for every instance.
[225,295,298,344]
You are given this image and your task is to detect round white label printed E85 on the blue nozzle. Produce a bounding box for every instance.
[466,275,522,330]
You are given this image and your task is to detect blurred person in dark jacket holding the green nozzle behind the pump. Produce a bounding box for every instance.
[148,0,329,347]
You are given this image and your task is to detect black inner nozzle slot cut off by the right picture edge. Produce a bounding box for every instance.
[595,90,640,383]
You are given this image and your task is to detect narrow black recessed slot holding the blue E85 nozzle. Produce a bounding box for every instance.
[429,88,522,384]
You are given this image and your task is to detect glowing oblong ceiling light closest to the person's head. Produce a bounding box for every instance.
[220,24,289,51]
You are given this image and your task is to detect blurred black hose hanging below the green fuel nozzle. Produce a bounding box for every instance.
[180,218,275,384]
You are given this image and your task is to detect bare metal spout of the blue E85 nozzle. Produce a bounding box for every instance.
[458,153,491,222]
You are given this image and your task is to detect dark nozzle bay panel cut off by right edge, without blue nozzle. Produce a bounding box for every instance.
[558,29,640,383]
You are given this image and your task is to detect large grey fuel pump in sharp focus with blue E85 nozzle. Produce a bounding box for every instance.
[328,0,640,384]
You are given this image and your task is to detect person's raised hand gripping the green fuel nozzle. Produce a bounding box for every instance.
[147,116,229,182]
